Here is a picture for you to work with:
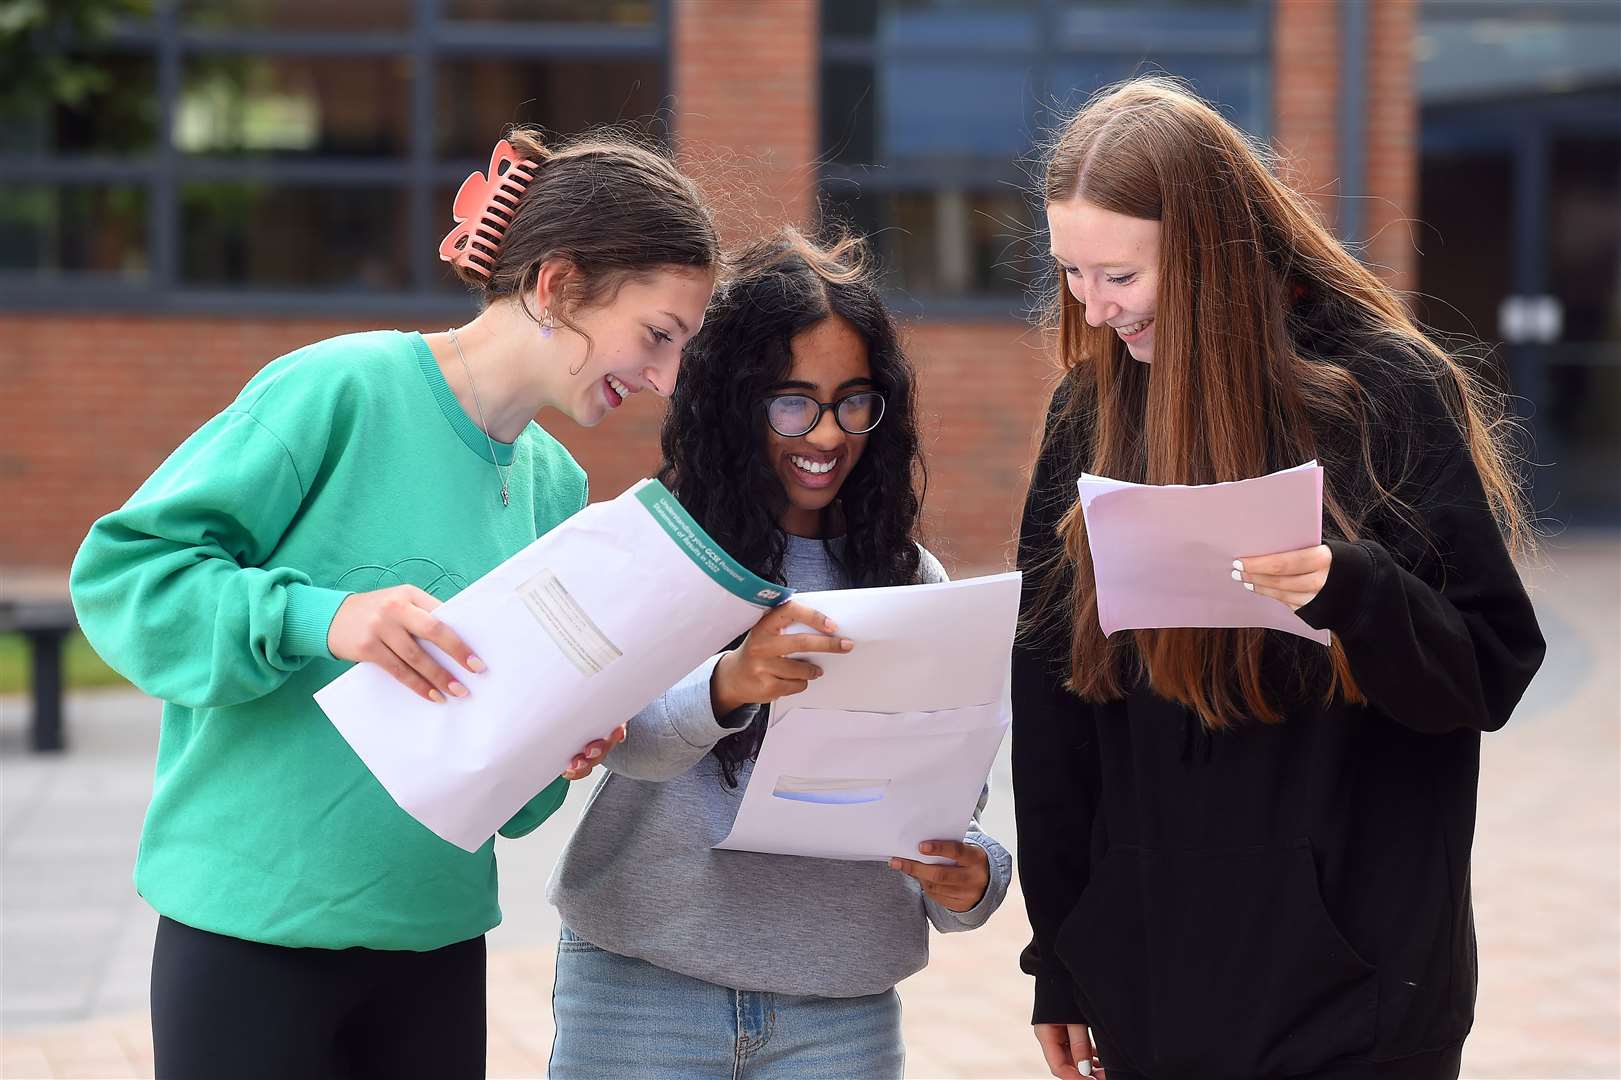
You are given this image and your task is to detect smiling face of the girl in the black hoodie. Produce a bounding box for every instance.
[1047,198,1159,363]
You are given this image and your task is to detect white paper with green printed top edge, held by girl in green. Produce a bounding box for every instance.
[314,480,788,851]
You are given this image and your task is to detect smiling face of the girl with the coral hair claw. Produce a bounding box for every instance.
[553,268,715,428]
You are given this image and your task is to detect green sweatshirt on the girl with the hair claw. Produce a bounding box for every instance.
[71,331,585,950]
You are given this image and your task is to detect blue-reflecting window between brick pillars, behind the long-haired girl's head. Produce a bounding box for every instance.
[822,0,1271,315]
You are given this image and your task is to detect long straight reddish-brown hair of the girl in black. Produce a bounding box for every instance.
[1036,76,1530,728]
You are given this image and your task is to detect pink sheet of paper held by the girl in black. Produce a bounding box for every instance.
[1078,462,1329,645]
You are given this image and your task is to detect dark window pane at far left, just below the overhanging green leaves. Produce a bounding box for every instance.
[0,54,157,154]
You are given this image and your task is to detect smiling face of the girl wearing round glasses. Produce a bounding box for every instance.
[762,315,877,537]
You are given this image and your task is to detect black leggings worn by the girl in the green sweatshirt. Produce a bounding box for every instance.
[152,918,485,1080]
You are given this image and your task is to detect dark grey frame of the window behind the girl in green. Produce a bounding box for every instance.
[0,0,671,316]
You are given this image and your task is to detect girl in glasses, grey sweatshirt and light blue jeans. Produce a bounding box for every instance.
[548,230,1012,1080]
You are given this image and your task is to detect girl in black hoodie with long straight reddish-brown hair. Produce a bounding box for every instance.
[1013,78,1543,1080]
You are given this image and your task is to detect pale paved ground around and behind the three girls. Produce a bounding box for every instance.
[0,534,1621,1080]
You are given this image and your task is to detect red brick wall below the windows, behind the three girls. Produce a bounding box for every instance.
[0,315,1047,572]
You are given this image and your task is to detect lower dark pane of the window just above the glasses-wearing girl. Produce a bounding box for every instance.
[825,188,1044,298]
